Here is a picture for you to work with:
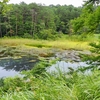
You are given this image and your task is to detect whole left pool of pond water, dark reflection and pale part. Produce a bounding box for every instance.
[0,56,39,78]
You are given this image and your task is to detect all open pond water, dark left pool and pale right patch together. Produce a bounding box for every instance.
[0,56,87,78]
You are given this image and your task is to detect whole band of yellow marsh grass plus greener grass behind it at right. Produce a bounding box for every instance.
[0,34,100,50]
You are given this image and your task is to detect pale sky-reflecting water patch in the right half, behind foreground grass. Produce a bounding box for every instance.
[47,61,88,73]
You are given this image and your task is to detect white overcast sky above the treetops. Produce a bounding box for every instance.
[9,0,83,7]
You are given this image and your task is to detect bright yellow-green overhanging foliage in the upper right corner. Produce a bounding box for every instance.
[70,0,100,34]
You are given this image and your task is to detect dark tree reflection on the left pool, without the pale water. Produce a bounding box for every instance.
[0,56,39,71]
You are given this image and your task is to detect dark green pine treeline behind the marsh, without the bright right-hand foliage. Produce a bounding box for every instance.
[0,2,82,39]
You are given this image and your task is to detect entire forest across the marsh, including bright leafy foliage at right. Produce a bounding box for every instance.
[0,0,100,39]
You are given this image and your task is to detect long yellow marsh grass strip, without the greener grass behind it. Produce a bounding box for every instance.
[0,38,90,50]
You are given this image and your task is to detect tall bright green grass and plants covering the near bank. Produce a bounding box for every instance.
[0,70,100,100]
